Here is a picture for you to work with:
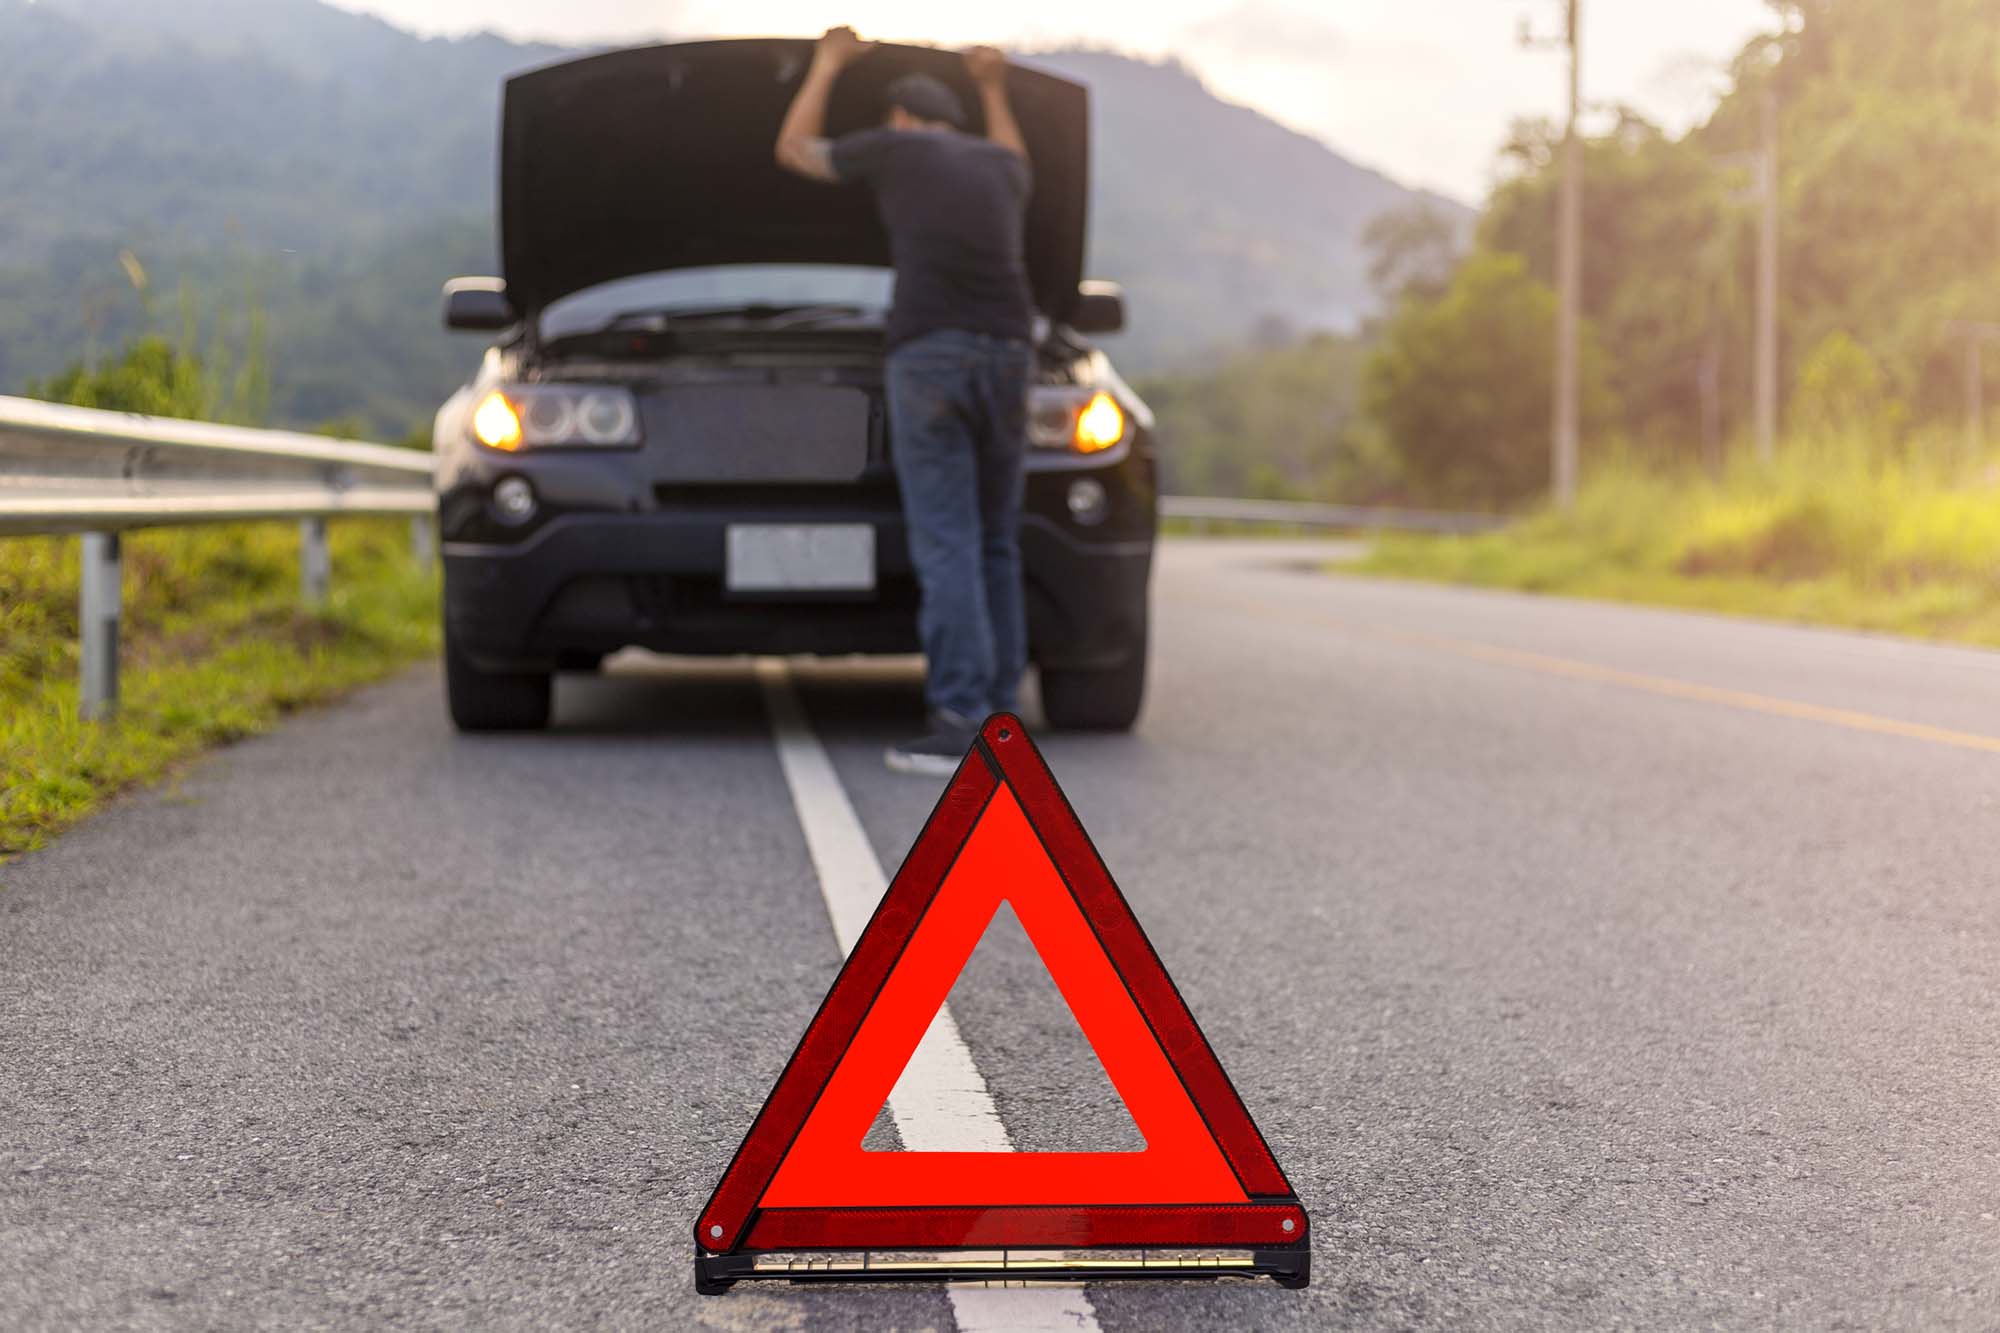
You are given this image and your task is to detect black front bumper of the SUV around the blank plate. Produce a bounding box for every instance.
[444,504,1152,671]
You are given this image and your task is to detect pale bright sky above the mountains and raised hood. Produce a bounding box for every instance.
[334,0,1772,204]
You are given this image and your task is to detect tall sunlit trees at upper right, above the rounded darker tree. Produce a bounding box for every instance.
[1478,0,2000,454]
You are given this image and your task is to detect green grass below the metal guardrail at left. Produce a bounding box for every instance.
[0,518,438,861]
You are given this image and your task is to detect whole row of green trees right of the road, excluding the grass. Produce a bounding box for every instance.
[1142,0,2000,498]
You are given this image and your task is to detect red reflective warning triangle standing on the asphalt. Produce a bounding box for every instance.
[694,713,1306,1289]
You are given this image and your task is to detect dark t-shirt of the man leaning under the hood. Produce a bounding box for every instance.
[832,130,1032,348]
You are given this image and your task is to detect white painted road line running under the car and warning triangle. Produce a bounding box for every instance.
[756,658,1098,1333]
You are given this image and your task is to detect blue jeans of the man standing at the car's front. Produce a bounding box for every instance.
[888,328,1032,721]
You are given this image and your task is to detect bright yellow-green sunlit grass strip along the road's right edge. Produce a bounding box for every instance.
[1342,436,2000,646]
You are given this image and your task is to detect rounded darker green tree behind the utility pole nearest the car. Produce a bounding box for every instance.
[1362,252,1616,506]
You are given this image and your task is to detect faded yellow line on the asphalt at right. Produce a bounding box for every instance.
[1200,598,2000,755]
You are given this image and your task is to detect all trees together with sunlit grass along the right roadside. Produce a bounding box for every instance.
[1146,0,2000,644]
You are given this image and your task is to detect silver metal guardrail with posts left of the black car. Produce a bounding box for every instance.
[0,396,436,719]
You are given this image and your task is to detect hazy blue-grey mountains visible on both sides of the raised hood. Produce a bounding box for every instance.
[0,0,1470,432]
